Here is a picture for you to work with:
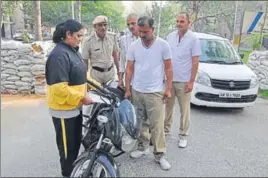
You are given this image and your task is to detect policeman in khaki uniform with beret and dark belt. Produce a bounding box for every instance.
[82,16,119,84]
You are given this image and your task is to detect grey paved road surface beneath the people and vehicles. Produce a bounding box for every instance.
[1,96,268,177]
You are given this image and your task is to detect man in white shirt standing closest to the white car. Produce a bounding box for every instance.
[165,13,201,148]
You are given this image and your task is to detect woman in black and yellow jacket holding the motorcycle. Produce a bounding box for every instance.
[46,20,92,177]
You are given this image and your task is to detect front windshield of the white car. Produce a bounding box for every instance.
[200,39,242,64]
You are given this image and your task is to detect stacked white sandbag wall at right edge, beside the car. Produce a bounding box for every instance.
[247,51,268,90]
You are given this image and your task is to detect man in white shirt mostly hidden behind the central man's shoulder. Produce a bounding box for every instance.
[118,13,139,87]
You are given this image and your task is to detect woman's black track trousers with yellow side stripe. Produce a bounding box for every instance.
[52,112,83,176]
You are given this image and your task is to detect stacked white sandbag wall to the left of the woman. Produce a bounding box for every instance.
[1,41,52,94]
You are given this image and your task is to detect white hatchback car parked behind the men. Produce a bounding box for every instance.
[191,33,259,108]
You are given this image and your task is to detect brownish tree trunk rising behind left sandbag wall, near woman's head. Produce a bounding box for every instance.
[33,0,43,41]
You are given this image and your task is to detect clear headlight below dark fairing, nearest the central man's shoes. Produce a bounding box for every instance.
[121,126,137,152]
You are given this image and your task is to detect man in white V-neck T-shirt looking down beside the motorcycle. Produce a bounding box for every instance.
[125,16,173,170]
